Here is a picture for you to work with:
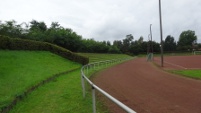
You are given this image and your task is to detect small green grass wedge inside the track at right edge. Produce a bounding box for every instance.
[172,70,201,79]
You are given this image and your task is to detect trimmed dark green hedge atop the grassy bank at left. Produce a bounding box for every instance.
[0,35,89,65]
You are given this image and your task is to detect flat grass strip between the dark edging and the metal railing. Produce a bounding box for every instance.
[10,70,107,113]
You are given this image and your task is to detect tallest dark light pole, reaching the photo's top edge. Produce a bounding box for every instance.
[159,0,163,67]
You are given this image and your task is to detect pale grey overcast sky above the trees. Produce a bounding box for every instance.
[0,0,201,42]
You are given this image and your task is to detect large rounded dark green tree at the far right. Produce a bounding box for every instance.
[178,30,197,50]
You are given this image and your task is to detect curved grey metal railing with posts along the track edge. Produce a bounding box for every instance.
[81,58,136,113]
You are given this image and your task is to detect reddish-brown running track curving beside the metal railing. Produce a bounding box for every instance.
[93,58,201,113]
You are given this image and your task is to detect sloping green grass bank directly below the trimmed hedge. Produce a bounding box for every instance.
[0,50,81,108]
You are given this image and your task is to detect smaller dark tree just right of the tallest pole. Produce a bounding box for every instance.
[164,35,176,51]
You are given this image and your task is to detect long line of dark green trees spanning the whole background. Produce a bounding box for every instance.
[0,20,201,55]
